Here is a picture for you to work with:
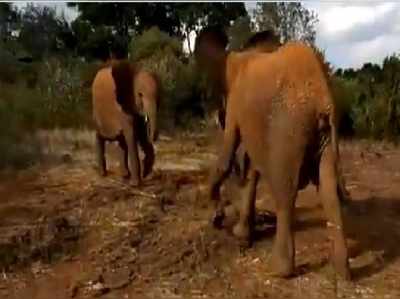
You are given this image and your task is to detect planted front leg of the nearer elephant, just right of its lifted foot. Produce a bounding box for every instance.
[233,170,259,246]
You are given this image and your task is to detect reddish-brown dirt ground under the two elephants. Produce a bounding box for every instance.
[0,132,400,299]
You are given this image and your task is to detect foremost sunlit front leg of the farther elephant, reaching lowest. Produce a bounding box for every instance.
[124,127,142,186]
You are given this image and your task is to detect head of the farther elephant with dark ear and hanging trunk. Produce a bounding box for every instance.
[112,61,160,142]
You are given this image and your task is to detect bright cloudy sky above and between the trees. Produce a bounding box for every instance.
[10,0,400,68]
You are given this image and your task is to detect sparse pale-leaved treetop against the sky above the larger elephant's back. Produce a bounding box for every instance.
[255,2,318,44]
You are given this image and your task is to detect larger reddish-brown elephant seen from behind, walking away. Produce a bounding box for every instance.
[195,28,350,278]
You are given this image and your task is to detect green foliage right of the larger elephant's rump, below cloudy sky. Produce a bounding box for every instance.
[336,55,400,139]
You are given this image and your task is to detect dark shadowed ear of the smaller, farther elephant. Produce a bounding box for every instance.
[111,61,135,114]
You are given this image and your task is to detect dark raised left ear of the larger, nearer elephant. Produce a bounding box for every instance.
[194,26,228,88]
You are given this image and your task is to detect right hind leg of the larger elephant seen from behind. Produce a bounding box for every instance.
[319,144,351,279]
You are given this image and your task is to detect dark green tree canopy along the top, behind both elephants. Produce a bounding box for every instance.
[68,2,247,57]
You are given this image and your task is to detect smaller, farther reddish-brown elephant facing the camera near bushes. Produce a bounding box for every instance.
[92,61,160,185]
